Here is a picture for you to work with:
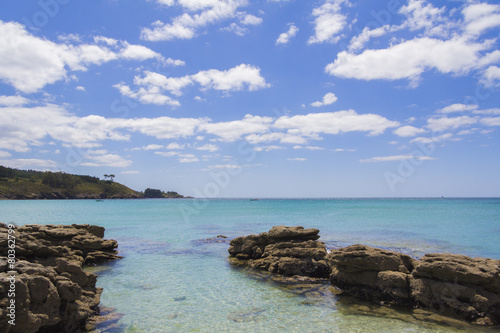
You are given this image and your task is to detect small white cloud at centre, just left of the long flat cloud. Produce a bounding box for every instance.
[200,114,273,142]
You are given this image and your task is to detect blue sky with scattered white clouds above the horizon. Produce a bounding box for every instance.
[0,0,500,198]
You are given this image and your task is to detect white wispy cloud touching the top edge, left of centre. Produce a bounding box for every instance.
[141,0,247,41]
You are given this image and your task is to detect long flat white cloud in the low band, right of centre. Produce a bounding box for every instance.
[274,110,399,136]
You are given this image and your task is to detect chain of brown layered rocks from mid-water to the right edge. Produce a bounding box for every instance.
[228,226,500,326]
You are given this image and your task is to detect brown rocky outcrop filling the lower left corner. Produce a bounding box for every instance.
[0,223,120,333]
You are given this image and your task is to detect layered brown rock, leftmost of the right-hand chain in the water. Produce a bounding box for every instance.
[229,226,330,278]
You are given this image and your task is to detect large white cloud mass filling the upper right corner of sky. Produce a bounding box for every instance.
[325,0,500,87]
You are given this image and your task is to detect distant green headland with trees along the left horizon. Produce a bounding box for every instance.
[0,165,184,199]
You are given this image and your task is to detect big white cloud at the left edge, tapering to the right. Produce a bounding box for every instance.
[0,20,178,93]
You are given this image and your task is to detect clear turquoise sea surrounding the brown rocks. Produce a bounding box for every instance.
[0,198,500,333]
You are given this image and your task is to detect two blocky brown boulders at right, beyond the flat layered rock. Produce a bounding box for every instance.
[327,245,500,325]
